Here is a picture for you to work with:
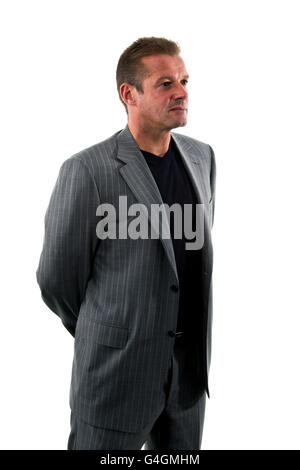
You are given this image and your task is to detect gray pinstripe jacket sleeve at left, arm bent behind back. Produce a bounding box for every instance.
[36,155,100,336]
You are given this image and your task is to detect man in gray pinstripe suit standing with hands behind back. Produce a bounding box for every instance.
[37,37,216,450]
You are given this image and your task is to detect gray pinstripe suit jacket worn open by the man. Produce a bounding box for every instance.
[36,125,216,432]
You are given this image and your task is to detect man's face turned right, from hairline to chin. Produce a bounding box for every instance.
[134,54,188,130]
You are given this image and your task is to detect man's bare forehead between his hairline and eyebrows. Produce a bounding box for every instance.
[142,54,187,80]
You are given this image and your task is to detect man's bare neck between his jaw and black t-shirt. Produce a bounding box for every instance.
[128,122,171,157]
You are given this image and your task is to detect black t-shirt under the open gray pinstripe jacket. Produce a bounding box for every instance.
[141,136,201,334]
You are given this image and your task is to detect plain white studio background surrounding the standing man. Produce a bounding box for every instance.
[0,0,300,450]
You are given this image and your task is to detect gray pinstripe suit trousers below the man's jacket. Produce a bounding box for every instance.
[67,338,206,450]
